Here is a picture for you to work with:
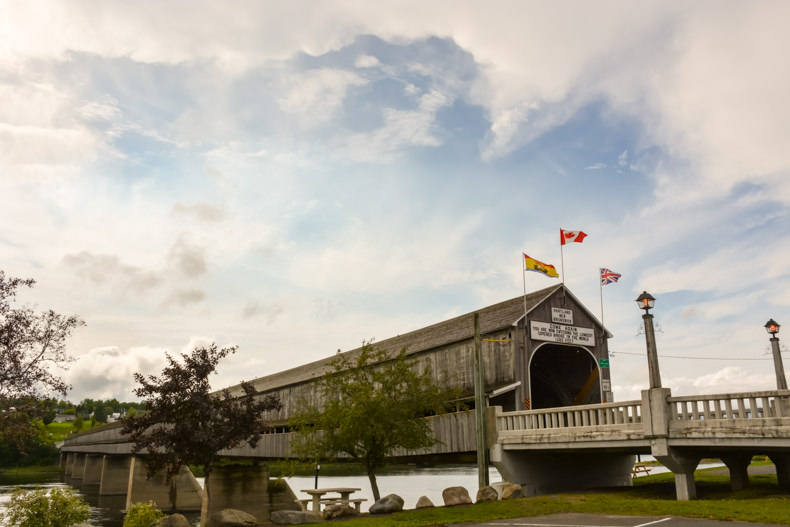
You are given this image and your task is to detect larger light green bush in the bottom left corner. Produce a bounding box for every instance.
[0,488,91,527]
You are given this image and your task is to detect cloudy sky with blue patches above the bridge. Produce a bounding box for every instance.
[0,0,790,402]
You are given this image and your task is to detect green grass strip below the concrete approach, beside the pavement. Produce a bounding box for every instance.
[324,471,790,527]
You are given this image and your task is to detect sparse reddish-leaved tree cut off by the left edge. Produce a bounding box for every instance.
[0,271,84,454]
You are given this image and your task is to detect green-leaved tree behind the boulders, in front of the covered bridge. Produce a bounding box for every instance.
[291,342,458,500]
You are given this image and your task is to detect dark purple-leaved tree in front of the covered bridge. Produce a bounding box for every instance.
[122,344,280,510]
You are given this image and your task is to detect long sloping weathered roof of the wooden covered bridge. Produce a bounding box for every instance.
[229,284,563,394]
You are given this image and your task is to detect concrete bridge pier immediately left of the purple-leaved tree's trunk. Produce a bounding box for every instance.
[126,457,203,511]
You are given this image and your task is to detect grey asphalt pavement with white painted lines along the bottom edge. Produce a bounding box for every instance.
[454,513,776,527]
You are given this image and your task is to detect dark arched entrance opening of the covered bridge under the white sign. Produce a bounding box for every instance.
[529,344,601,410]
